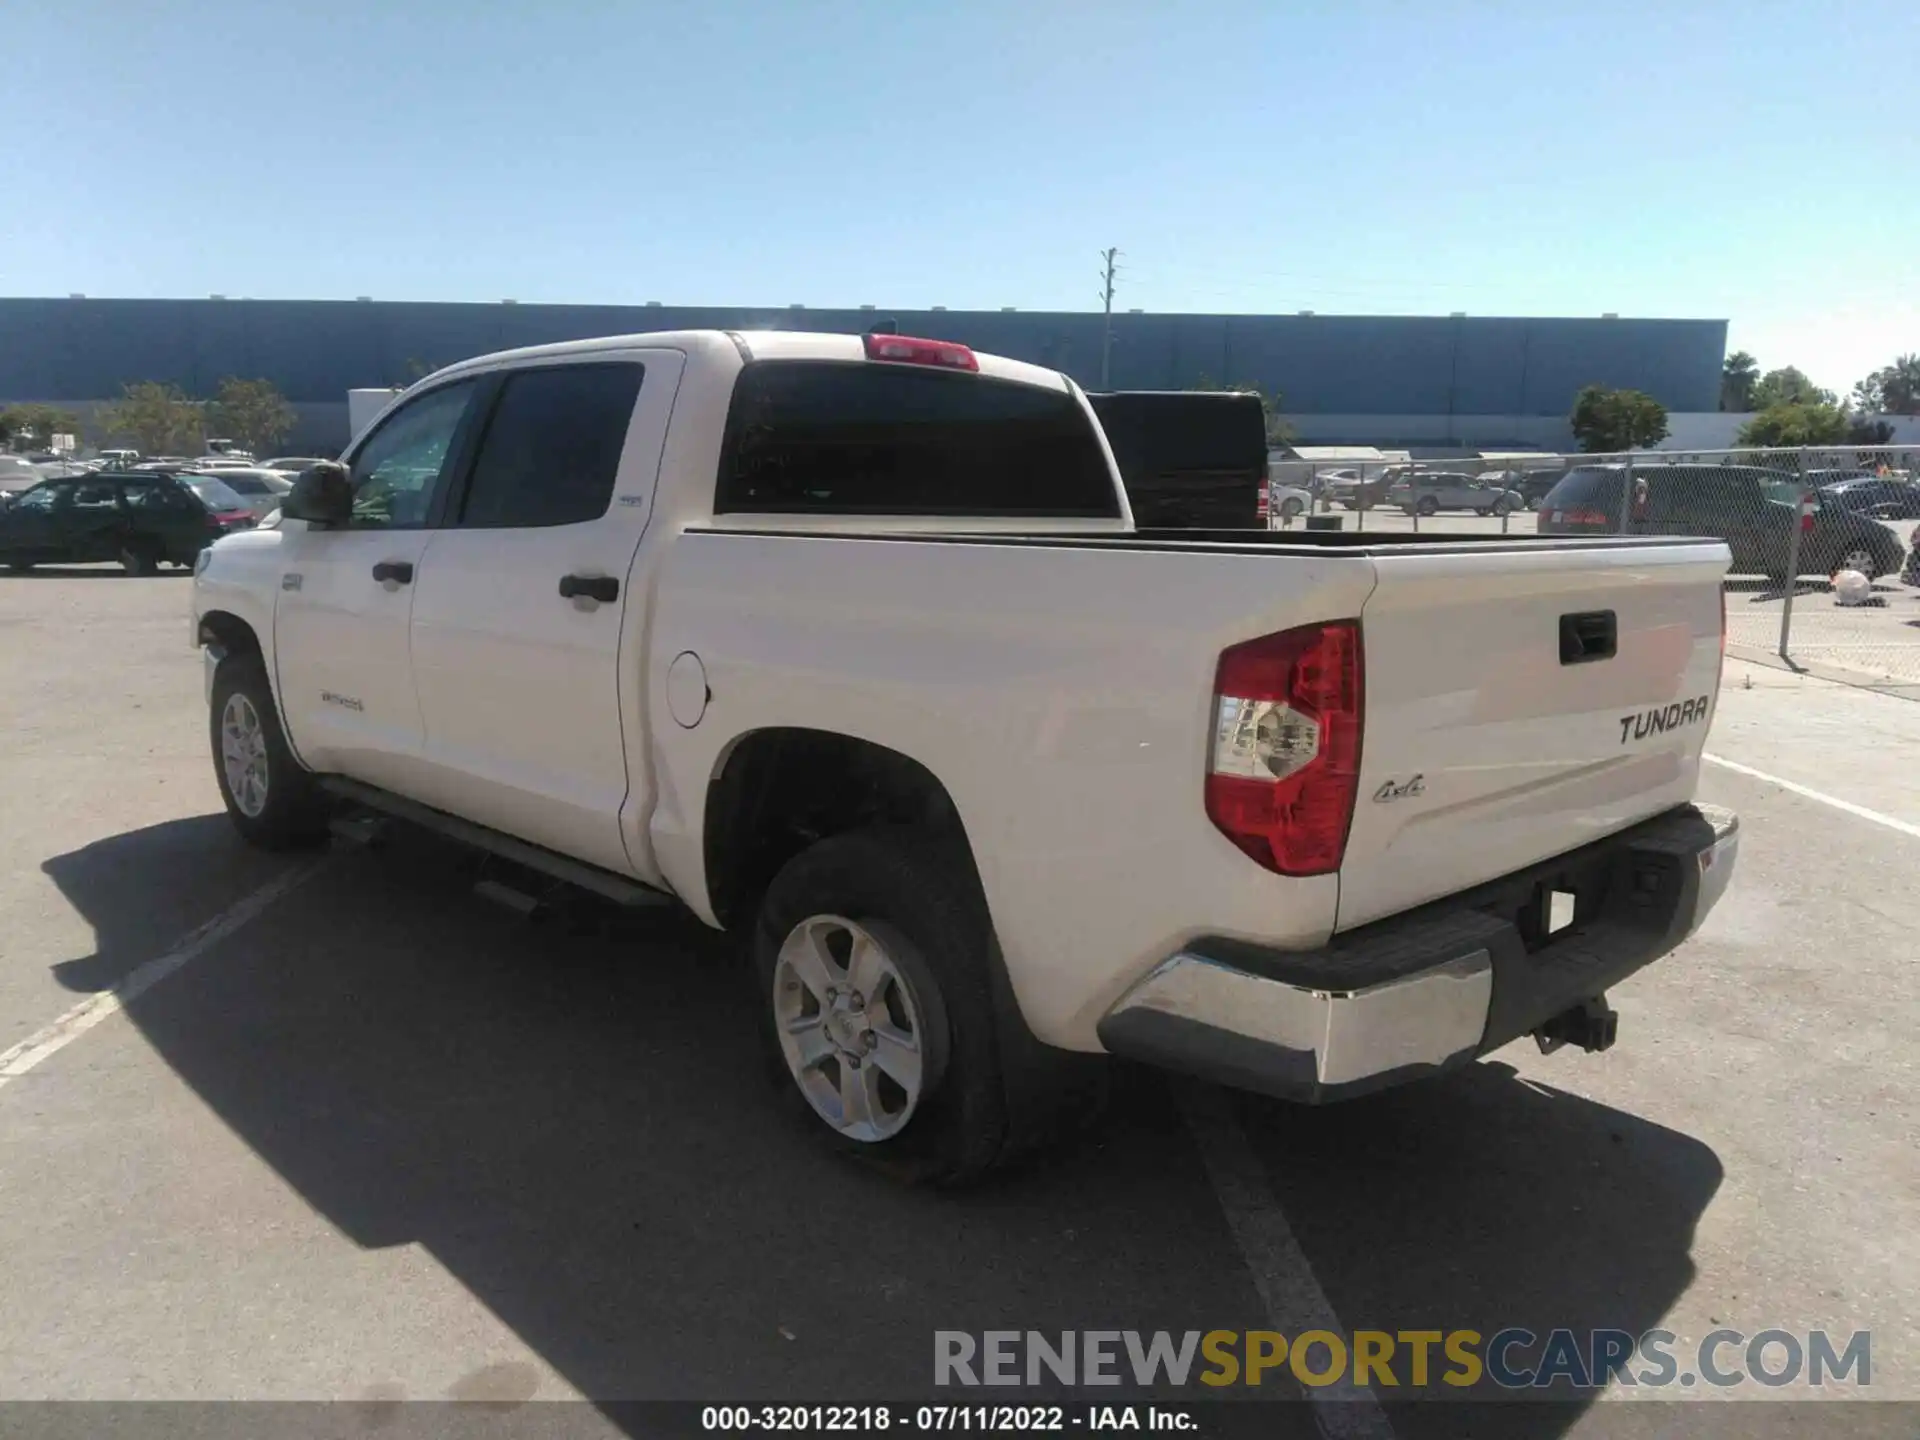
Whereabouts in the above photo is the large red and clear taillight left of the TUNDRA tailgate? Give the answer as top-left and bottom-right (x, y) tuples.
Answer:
(1206, 620), (1361, 876)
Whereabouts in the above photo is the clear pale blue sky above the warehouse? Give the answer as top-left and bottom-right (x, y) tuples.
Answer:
(0, 0), (1920, 390)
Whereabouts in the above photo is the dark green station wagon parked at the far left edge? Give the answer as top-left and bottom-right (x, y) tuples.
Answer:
(0, 470), (253, 574)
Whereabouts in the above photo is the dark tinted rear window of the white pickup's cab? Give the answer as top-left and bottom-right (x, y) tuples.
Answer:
(714, 361), (1119, 516)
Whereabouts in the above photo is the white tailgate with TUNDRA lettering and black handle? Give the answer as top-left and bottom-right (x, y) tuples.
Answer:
(1336, 541), (1728, 929)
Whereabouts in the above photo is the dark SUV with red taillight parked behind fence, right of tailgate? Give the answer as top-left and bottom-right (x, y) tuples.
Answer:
(1534, 463), (1905, 582)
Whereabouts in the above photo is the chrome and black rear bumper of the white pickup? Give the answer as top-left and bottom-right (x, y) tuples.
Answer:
(1100, 806), (1740, 1102)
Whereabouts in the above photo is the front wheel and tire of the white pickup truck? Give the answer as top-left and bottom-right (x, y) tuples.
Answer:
(209, 655), (326, 851)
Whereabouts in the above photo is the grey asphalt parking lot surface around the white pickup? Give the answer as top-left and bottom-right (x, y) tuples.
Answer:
(0, 568), (1920, 1440)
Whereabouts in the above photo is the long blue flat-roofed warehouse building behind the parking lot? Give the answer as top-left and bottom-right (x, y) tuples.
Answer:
(0, 296), (1726, 451)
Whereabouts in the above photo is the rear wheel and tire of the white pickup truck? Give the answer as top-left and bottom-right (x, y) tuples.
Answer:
(753, 828), (1082, 1185)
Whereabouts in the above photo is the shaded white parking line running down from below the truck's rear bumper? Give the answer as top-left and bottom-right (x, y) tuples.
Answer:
(1175, 1081), (1394, 1440)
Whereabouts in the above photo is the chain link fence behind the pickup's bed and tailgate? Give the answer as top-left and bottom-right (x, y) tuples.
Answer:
(1269, 445), (1920, 695)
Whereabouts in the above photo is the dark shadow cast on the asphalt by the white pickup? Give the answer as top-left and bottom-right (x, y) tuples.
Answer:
(46, 818), (1720, 1440)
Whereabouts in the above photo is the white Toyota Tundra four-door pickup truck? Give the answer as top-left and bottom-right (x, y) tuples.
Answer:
(192, 332), (1738, 1181)
